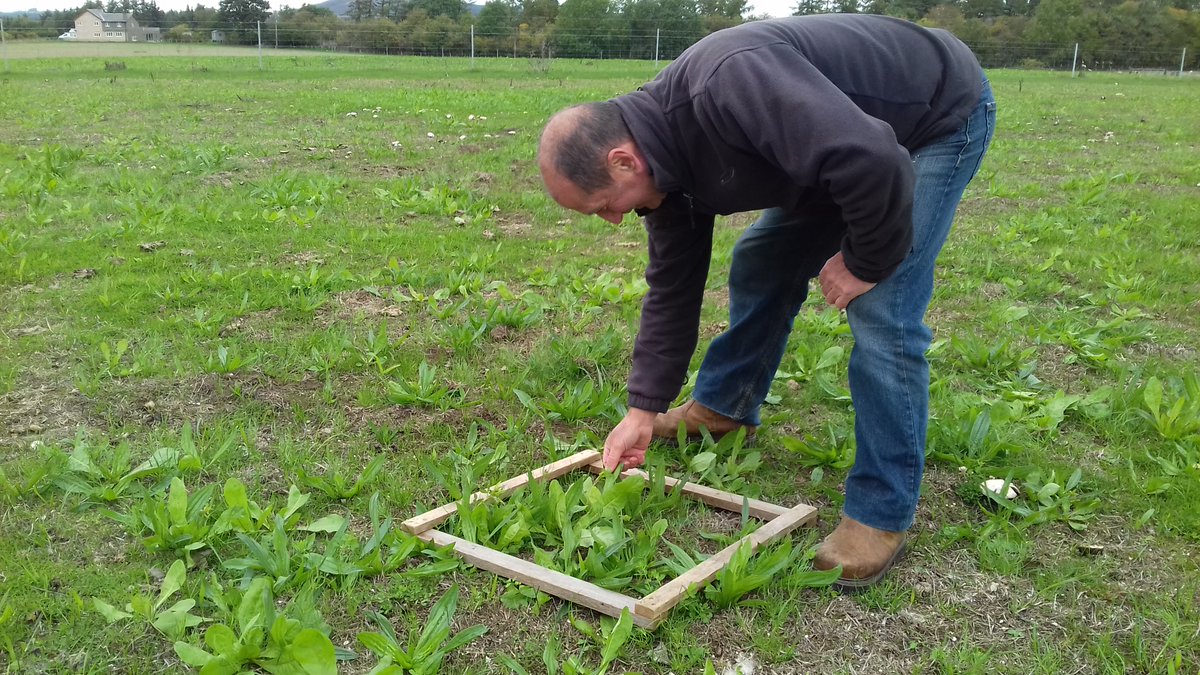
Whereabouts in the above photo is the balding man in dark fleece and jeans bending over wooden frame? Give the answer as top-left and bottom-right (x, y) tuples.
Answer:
(539, 14), (995, 590)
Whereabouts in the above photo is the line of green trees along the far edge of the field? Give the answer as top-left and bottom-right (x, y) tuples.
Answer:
(6, 0), (1200, 68)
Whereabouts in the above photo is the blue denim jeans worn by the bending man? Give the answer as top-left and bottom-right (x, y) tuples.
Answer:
(692, 78), (996, 532)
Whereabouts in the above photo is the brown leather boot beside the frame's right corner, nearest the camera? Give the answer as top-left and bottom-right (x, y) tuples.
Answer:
(812, 515), (906, 592)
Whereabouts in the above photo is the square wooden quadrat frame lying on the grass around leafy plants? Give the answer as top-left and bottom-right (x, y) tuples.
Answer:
(401, 450), (817, 629)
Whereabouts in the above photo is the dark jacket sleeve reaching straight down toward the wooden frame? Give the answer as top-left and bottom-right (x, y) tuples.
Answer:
(629, 193), (713, 412)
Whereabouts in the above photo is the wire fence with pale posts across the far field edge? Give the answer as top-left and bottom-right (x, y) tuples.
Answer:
(0, 22), (1200, 74)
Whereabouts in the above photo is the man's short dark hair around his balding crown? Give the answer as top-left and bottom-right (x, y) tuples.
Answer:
(554, 101), (632, 195)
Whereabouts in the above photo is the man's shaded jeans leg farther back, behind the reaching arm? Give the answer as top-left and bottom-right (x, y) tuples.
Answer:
(692, 209), (845, 425)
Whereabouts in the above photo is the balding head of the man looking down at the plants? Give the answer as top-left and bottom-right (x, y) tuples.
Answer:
(538, 101), (665, 223)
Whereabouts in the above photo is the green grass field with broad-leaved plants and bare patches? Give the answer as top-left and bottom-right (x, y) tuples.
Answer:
(0, 46), (1200, 674)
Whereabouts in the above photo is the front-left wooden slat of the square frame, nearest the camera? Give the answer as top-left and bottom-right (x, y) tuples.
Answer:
(418, 530), (660, 628)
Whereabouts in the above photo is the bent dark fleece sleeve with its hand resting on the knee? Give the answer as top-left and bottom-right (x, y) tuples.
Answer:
(697, 44), (914, 282)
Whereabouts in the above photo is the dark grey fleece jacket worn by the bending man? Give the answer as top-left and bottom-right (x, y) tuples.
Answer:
(613, 14), (983, 412)
